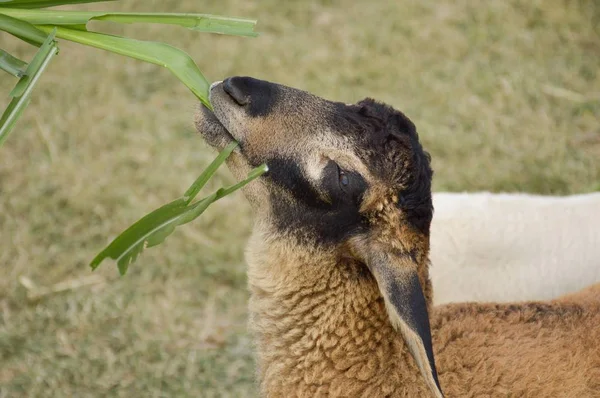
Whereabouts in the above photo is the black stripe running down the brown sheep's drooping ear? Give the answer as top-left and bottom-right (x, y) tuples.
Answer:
(388, 273), (442, 391)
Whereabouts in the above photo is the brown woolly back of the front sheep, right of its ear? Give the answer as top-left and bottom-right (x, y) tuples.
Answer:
(431, 297), (600, 398)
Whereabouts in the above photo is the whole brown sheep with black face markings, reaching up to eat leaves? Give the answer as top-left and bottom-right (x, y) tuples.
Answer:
(195, 77), (600, 398)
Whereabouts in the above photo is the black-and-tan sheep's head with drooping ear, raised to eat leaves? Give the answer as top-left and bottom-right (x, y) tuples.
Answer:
(196, 77), (441, 396)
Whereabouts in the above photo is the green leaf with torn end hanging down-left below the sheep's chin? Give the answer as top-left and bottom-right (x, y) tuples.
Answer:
(90, 165), (268, 275)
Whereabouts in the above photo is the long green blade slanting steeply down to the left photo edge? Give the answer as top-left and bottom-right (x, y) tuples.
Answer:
(0, 28), (58, 146)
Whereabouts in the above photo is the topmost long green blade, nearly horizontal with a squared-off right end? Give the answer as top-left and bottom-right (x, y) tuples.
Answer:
(2, 8), (257, 36)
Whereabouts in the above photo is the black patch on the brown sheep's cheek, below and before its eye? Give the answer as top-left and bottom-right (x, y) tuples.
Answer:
(265, 158), (367, 244)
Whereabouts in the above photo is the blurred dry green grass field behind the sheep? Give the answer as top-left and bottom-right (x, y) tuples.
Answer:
(0, 0), (600, 398)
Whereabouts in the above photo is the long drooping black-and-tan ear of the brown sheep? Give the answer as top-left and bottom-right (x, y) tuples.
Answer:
(367, 252), (444, 397)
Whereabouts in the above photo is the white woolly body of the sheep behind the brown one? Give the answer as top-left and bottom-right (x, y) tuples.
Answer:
(430, 192), (600, 304)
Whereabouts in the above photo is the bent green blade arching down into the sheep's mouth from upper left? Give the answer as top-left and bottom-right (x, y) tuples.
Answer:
(38, 26), (210, 107)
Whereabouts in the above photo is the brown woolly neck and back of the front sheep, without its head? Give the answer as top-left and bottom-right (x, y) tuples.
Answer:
(248, 235), (600, 398)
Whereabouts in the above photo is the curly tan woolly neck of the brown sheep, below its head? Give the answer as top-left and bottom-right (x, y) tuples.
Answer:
(247, 233), (431, 397)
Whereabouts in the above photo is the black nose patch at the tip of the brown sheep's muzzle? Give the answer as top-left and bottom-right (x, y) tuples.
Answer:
(223, 76), (281, 117)
